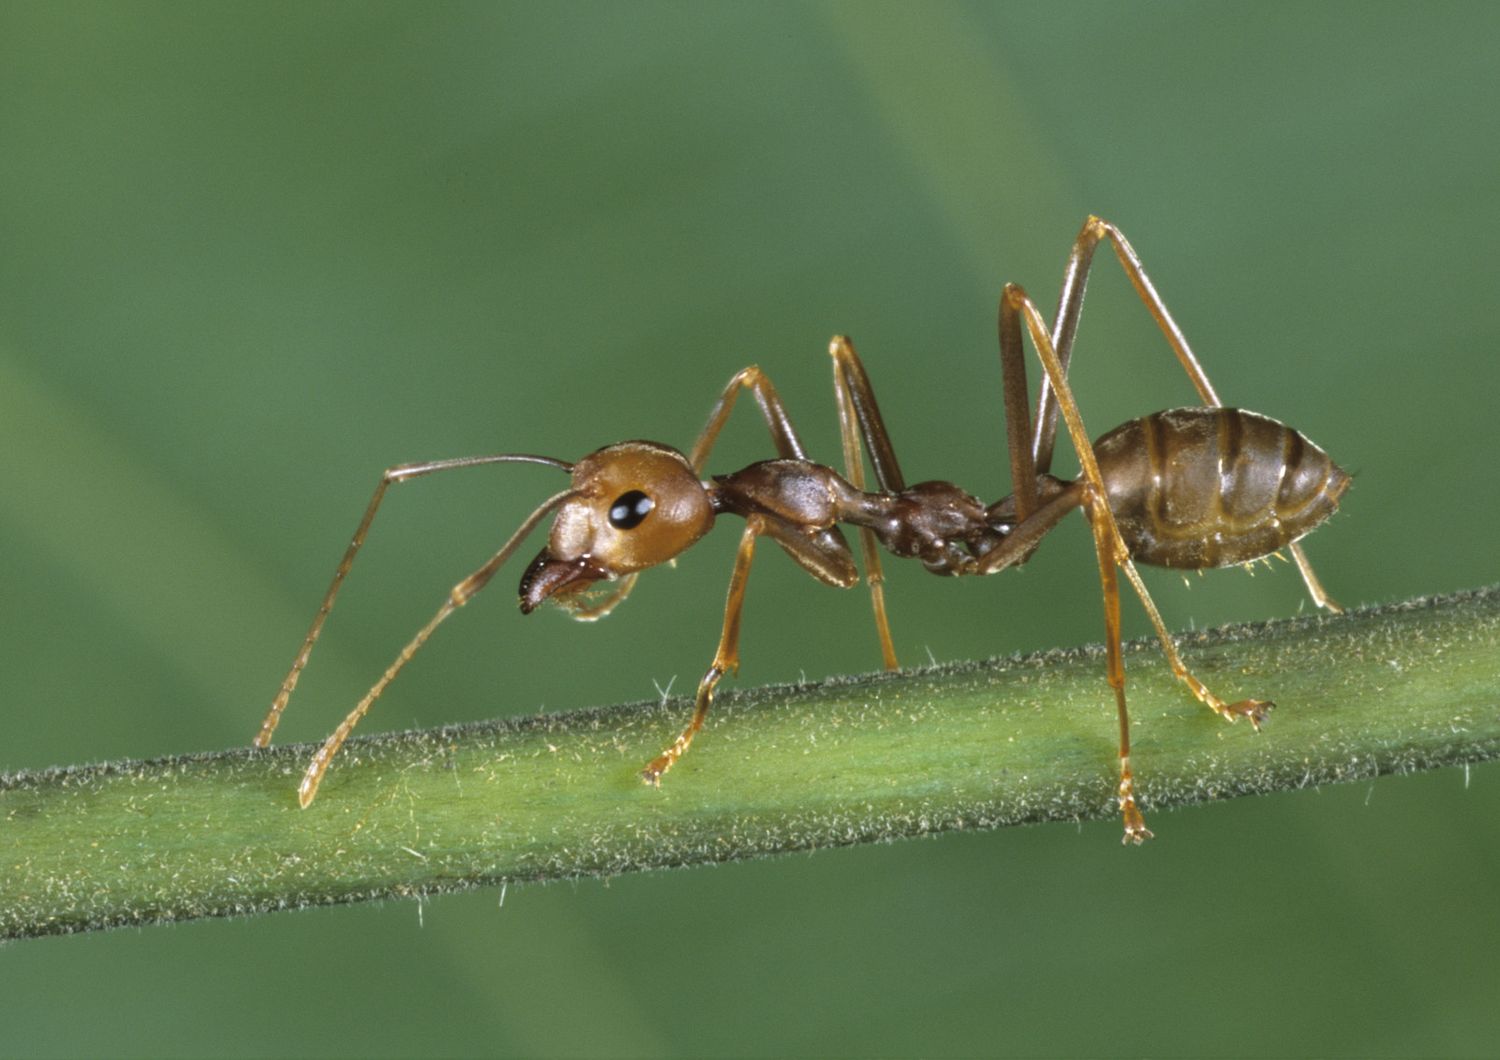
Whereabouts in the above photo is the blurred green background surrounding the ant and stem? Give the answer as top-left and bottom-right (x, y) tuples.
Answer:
(0, 3), (1500, 1056)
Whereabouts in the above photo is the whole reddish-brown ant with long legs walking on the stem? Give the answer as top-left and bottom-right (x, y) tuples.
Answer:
(255, 217), (1350, 844)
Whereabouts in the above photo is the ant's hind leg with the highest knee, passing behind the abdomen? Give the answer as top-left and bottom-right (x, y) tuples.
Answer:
(1032, 216), (1344, 613)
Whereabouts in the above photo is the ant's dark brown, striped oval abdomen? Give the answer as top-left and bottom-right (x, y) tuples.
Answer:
(1094, 406), (1349, 570)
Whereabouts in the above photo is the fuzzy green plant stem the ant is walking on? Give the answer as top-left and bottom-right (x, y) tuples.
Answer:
(0, 588), (1500, 937)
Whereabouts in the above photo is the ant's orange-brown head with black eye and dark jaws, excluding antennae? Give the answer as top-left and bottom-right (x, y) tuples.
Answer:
(521, 442), (714, 613)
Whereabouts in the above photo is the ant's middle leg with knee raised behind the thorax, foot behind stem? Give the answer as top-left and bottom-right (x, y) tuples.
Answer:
(828, 334), (906, 670)
